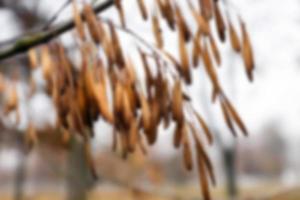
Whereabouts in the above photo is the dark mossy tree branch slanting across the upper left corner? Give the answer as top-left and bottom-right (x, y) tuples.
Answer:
(0, 0), (114, 61)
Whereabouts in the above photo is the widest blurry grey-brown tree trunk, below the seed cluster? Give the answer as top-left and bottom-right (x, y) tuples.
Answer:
(67, 137), (94, 200)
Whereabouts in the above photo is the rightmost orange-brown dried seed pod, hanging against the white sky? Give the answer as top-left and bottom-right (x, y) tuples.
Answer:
(240, 20), (255, 81)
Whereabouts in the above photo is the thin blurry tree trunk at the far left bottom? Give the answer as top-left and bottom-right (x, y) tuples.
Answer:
(14, 152), (26, 200)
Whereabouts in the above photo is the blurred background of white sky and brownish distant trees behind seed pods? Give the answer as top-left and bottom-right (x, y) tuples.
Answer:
(0, 0), (300, 200)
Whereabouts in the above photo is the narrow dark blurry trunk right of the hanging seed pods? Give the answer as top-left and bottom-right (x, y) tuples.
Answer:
(222, 146), (238, 200)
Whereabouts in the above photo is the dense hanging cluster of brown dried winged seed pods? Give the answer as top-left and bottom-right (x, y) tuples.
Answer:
(0, 0), (254, 200)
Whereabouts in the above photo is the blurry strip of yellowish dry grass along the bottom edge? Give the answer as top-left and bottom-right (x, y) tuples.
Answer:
(0, 183), (300, 200)
